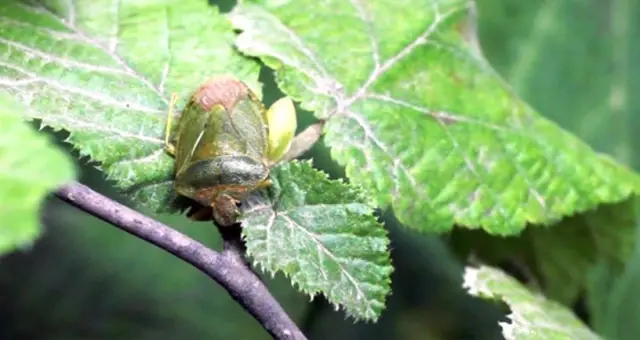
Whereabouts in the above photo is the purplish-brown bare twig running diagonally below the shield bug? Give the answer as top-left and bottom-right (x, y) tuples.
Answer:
(56, 182), (306, 340)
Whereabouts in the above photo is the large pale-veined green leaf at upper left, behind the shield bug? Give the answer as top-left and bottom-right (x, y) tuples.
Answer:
(0, 0), (261, 211)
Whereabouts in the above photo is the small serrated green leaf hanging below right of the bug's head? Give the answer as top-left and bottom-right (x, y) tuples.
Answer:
(243, 161), (392, 320)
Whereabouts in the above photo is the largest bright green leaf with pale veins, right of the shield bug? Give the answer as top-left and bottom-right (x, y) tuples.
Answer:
(230, 0), (640, 235)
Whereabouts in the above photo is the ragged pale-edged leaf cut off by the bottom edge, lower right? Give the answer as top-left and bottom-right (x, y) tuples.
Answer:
(464, 266), (600, 340)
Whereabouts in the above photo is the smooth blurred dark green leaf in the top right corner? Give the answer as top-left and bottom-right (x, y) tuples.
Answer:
(478, 0), (640, 170)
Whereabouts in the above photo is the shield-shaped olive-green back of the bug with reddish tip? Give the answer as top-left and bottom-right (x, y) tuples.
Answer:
(174, 77), (269, 217)
